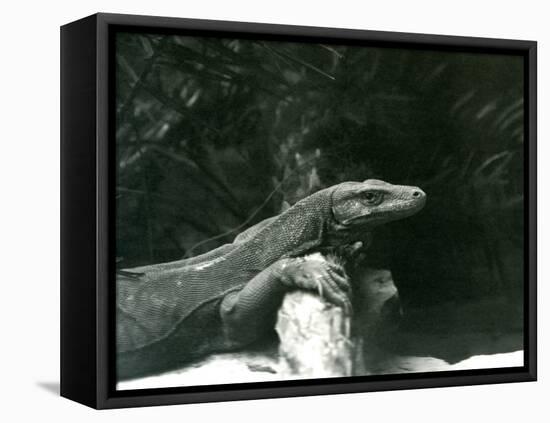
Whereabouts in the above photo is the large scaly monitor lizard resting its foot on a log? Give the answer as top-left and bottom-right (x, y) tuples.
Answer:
(116, 179), (426, 380)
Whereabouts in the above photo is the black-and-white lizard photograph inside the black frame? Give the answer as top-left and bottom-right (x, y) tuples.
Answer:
(113, 29), (527, 391)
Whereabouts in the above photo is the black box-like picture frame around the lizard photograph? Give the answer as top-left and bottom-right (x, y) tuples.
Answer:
(61, 13), (537, 409)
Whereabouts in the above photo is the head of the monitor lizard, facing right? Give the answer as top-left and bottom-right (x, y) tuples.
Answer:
(331, 179), (426, 243)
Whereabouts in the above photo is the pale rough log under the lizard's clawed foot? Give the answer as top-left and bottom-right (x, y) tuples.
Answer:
(275, 266), (397, 378)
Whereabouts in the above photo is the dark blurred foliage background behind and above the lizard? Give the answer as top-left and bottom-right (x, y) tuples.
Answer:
(116, 33), (524, 305)
